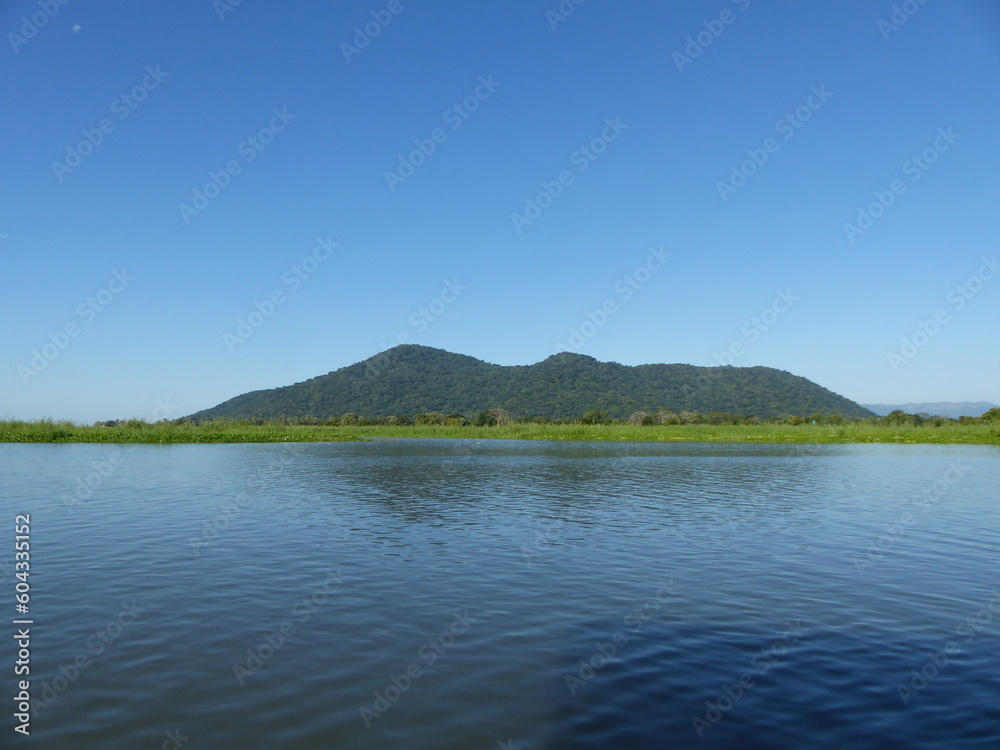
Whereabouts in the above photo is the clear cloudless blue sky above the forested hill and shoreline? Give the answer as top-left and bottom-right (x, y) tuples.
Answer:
(0, 0), (1000, 423)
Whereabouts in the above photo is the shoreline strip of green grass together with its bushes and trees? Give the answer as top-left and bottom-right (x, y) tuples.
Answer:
(0, 410), (1000, 445)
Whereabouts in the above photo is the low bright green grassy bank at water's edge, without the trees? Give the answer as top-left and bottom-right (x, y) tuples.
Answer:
(0, 421), (1000, 445)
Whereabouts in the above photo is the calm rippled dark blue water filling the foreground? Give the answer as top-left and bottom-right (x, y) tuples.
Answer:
(0, 440), (1000, 750)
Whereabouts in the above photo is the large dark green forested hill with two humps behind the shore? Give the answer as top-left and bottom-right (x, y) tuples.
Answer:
(190, 345), (873, 420)
